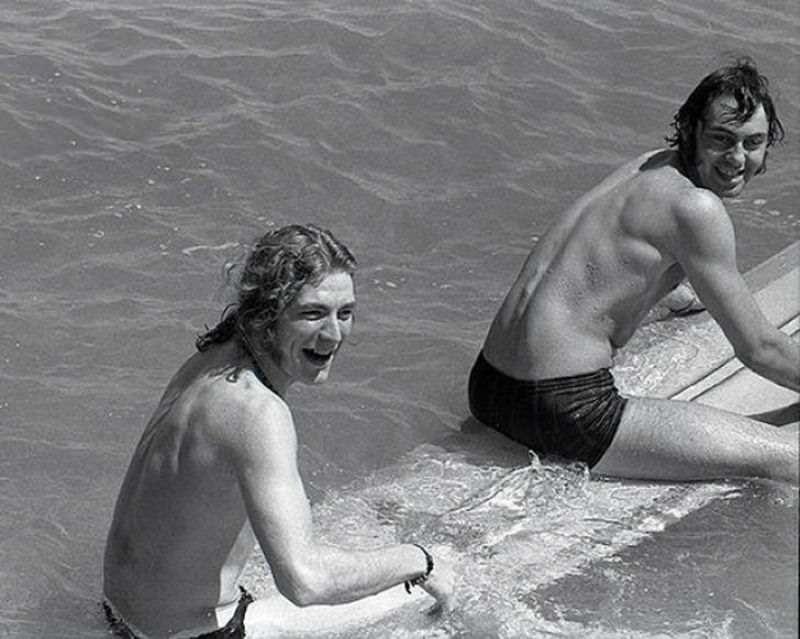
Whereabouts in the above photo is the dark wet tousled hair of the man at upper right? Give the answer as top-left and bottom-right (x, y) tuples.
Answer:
(666, 56), (784, 172)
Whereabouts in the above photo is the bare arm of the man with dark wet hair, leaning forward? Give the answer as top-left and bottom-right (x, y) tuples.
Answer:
(670, 192), (800, 391)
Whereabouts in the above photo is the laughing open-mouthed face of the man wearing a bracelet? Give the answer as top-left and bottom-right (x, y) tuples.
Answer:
(273, 271), (356, 384)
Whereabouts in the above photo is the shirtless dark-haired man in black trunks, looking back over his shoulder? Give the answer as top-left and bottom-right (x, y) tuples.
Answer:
(469, 59), (800, 484)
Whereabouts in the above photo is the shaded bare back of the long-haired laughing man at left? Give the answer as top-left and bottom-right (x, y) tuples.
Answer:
(104, 344), (278, 636)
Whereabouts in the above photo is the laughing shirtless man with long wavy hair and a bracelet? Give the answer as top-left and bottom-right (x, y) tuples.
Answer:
(104, 225), (454, 639)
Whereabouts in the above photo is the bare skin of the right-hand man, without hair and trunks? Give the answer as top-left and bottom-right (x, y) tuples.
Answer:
(478, 84), (800, 485)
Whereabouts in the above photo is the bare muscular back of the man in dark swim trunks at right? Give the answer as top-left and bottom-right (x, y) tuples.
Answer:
(483, 151), (694, 379)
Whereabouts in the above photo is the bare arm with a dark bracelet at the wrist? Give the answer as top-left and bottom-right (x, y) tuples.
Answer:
(225, 398), (452, 607)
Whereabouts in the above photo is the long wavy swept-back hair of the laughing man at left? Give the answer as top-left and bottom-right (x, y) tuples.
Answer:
(195, 224), (357, 351)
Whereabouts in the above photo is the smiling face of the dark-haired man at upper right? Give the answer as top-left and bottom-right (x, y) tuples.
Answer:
(695, 95), (768, 197)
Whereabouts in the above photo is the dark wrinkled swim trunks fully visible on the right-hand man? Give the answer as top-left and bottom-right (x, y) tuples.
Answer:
(469, 353), (628, 468)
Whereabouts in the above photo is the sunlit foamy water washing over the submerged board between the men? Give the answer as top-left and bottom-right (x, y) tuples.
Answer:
(244, 445), (739, 639)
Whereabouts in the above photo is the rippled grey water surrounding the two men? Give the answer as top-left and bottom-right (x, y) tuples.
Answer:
(0, 0), (800, 638)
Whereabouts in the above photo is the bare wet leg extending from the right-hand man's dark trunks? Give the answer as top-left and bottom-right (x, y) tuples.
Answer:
(592, 397), (798, 484)
